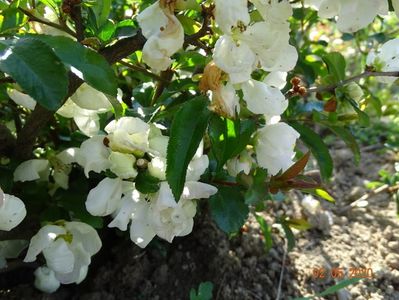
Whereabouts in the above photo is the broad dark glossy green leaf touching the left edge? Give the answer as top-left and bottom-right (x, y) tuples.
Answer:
(0, 38), (68, 110)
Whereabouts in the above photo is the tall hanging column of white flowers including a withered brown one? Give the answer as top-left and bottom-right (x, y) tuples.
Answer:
(200, 0), (299, 176)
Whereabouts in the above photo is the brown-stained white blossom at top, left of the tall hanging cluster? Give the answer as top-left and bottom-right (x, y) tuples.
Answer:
(137, 1), (184, 71)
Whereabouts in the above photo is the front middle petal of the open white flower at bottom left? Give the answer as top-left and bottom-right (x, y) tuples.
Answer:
(43, 238), (75, 274)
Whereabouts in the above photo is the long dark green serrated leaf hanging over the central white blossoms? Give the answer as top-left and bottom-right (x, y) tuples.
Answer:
(166, 96), (211, 201)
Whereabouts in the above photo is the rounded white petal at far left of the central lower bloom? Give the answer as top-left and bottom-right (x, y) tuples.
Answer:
(86, 178), (122, 216)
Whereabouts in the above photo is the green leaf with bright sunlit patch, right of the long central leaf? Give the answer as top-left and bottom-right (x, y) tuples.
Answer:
(208, 115), (256, 170)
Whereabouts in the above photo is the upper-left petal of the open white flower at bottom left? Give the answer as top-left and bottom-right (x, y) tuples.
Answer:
(24, 225), (66, 262)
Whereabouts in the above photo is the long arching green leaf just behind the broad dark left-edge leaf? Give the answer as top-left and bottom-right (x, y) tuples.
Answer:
(28, 35), (118, 96)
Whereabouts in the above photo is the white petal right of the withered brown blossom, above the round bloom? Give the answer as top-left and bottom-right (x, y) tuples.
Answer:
(241, 79), (288, 117)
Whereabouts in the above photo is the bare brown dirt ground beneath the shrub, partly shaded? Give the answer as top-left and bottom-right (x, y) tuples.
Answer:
(0, 144), (399, 300)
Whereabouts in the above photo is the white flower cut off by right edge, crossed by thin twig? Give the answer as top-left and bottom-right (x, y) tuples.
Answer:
(367, 39), (399, 83)
